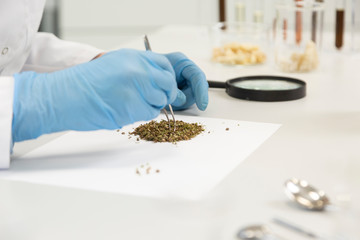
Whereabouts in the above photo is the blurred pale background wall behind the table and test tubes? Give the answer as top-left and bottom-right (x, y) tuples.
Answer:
(42, 0), (360, 49)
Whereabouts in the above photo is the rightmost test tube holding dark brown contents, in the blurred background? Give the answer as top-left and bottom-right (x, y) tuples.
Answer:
(335, 0), (346, 49)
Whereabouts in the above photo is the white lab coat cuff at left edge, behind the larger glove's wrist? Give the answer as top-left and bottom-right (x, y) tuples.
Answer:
(0, 77), (14, 169)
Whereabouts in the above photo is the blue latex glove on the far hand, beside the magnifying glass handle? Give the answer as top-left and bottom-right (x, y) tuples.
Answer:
(165, 53), (209, 111)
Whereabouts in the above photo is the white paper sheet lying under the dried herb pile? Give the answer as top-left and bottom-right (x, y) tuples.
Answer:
(0, 115), (280, 200)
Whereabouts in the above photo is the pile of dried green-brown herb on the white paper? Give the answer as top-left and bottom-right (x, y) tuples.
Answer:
(130, 120), (205, 143)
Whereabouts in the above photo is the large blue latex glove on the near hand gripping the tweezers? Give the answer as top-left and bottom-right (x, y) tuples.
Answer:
(13, 49), (186, 142)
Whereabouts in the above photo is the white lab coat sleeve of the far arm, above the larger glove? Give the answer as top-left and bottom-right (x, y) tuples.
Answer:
(22, 32), (104, 72)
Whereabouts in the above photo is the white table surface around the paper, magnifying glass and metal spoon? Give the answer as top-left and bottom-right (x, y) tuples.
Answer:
(0, 26), (360, 240)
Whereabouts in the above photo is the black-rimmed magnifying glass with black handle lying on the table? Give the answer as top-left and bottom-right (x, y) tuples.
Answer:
(208, 75), (306, 102)
